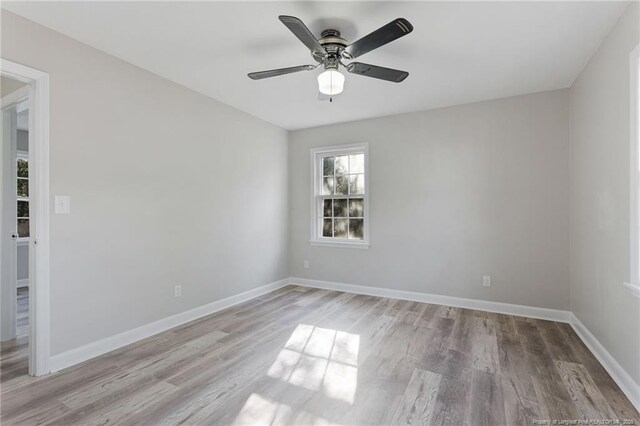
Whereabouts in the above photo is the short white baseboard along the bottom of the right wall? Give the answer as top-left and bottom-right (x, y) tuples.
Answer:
(571, 312), (640, 412)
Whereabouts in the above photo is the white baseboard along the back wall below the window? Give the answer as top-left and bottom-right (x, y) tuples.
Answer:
(290, 278), (571, 323)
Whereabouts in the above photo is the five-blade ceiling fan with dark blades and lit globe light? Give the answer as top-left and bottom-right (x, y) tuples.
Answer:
(247, 15), (413, 100)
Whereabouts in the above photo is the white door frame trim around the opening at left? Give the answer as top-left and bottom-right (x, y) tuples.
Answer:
(0, 58), (51, 376)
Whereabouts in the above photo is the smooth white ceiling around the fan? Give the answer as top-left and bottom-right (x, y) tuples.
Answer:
(2, 1), (628, 129)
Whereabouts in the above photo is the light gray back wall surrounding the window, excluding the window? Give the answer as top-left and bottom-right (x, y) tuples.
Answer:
(289, 90), (569, 309)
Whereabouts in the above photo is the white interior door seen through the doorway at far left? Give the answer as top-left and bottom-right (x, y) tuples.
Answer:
(0, 106), (18, 341)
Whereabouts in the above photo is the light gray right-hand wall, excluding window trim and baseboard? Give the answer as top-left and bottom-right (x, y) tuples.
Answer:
(570, 2), (640, 383)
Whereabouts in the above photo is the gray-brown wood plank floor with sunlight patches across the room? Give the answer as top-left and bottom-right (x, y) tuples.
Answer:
(1, 286), (640, 425)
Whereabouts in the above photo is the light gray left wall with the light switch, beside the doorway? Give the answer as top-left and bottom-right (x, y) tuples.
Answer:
(2, 11), (288, 355)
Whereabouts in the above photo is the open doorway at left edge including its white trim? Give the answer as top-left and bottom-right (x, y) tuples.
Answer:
(0, 59), (50, 376)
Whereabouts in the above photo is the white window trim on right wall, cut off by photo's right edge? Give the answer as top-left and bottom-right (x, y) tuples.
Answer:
(624, 44), (640, 296)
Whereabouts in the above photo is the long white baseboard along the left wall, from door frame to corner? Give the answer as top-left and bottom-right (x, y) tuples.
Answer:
(50, 279), (290, 372)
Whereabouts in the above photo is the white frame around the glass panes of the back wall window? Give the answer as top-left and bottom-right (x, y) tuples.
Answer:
(309, 142), (371, 249)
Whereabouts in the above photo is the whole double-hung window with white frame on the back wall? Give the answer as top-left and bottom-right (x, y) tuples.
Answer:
(311, 144), (369, 248)
